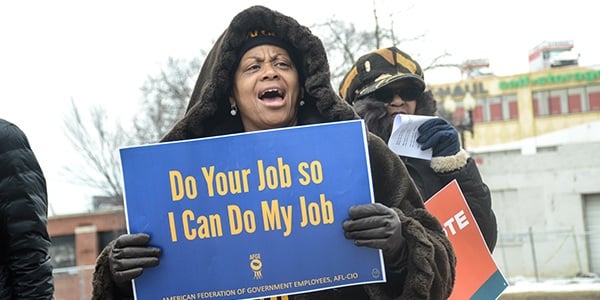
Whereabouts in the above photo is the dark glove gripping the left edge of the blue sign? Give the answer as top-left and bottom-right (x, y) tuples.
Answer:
(108, 233), (162, 289)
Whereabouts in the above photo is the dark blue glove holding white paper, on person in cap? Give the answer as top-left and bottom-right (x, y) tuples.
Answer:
(417, 118), (460, 156)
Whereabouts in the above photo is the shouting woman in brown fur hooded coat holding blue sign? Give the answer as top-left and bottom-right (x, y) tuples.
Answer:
(92, 6), (456, 300)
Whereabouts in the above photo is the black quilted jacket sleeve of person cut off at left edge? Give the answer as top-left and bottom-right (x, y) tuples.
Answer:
(0, 119), (54, 299)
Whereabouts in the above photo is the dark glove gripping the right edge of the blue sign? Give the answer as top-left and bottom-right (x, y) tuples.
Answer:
(342, 203), (406, 261)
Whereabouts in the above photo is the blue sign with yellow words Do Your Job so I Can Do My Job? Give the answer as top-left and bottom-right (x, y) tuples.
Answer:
(120, 120), (385, 299)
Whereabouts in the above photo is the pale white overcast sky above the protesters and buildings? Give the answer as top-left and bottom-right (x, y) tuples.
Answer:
(0, 0), (600, 214)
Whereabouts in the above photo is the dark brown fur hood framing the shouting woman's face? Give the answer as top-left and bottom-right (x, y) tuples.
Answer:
(162, 6), (358, 142)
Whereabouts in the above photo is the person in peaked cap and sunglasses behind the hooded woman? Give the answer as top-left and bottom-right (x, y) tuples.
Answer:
(339, 47), (498, 252)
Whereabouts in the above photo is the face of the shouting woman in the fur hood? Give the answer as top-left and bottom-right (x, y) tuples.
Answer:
(230, 45), (300, 131)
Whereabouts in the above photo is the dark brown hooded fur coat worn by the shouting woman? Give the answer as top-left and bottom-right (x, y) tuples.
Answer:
(93, 6), (455, 300)
